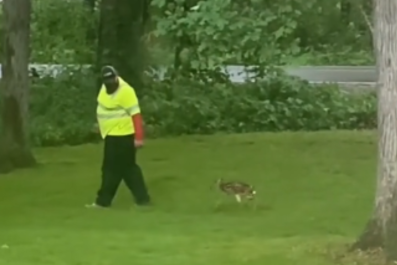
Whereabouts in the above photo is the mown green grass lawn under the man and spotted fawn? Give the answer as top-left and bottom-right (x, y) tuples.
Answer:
(0, 132), (376, 265)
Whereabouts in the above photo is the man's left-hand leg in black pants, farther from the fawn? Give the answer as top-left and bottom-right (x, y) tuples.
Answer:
(95, 136), (122, 207)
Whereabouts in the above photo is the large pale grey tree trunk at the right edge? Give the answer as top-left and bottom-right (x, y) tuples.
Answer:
(354, 0), (397, 261)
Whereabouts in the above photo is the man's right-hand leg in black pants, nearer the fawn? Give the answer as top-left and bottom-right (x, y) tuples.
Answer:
(119, 136), (150, 205)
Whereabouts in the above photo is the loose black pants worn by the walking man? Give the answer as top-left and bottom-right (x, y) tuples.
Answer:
(96, 135), (150, 207)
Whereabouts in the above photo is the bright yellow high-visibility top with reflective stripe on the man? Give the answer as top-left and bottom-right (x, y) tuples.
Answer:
(96, 77), (141, 139)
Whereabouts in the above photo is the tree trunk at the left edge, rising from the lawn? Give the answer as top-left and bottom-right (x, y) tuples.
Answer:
(0, 0), (36, 173)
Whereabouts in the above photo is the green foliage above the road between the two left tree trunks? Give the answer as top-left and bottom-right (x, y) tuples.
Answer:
(31, 0), (98, 64)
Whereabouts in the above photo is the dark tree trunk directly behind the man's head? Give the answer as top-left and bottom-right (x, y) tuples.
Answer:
(97, 0), (148, 94)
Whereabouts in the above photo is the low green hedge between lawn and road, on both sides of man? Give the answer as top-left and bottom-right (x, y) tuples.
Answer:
(3, 69), (376, 146)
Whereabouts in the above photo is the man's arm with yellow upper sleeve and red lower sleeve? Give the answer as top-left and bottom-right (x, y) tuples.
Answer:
(120, 88), (144, 141)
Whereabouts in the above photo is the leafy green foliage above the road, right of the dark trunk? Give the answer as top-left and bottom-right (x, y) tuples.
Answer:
(152, 0), (373, 69)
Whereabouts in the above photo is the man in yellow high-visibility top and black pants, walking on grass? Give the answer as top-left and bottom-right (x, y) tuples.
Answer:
(87, 66), (150, 207)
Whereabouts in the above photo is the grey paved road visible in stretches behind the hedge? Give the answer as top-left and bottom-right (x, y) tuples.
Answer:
(0, 64), (377, 83)
